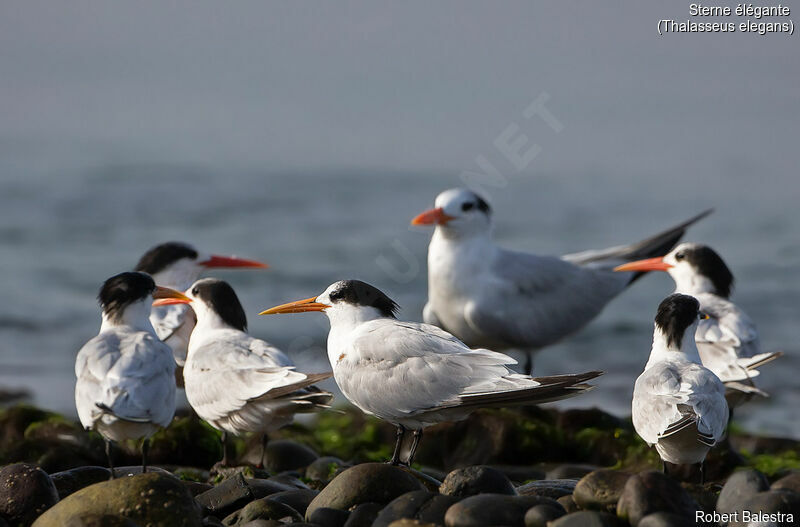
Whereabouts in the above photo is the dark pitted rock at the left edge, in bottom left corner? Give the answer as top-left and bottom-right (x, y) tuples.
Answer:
(0, 463), (58, 525)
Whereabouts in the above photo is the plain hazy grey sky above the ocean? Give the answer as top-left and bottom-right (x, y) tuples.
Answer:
(0, 0), (800, 192)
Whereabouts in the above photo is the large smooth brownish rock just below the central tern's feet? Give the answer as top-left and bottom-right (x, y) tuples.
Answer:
(306, 463), (422, 519)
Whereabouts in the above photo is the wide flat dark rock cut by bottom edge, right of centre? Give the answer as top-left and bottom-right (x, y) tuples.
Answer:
(444, 494), (559, 527)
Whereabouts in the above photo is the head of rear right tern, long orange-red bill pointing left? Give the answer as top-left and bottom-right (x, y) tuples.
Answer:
(614, 243), (733, 298)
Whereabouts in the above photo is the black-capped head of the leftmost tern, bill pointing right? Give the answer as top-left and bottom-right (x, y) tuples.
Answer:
(97, 271), (189, 322)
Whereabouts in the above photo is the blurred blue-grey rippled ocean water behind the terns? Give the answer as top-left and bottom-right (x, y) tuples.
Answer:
(0, 165), (800, 438)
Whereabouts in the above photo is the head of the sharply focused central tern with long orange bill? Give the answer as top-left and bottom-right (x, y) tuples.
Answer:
(260, 280), (399, 320)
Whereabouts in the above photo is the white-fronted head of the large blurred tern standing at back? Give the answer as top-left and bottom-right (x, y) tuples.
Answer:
(411, 188), (492, 236)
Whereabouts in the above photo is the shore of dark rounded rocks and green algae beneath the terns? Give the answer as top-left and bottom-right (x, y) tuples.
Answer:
(0, 405), (800, 527)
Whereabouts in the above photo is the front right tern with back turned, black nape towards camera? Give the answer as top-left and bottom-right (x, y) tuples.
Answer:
(632, 294), (728, 480)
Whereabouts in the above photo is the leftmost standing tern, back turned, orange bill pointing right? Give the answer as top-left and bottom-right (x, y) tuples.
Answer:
(75, 272), (190, 477)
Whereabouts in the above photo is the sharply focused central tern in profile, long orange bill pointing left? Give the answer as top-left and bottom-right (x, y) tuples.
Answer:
(261, 280), (602, 465)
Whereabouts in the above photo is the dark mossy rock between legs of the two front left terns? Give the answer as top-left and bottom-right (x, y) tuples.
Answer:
(149, 415), (222, 467)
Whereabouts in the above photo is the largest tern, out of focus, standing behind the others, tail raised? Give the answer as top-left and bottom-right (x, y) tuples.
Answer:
(411, 189), (711, 374)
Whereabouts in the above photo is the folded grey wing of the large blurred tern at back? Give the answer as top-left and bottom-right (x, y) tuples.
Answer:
(465, 251), (629, 348)
